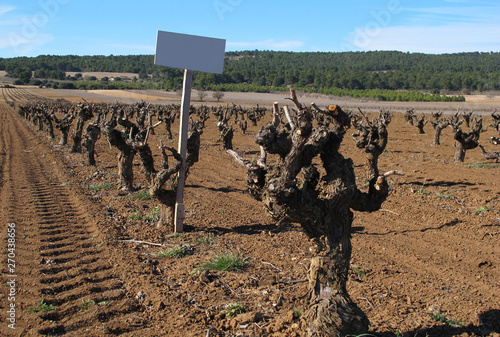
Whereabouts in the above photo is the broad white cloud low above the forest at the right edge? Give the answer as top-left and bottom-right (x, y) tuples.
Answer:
(347, 23), (500, 54)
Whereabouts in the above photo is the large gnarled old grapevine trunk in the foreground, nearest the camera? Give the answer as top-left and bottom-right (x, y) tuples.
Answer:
(228, 94), (396, 336)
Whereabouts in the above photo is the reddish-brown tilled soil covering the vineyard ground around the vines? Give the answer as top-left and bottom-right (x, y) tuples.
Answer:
(0, 89), (500, 337)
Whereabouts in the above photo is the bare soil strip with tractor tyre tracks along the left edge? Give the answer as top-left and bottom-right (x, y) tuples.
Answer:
(0, 102), (144, 336)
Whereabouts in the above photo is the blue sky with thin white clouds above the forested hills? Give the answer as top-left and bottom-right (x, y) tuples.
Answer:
(0, 0), (500, 57)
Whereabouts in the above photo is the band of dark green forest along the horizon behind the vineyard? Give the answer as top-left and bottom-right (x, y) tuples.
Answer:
(0, 50), (500, 101)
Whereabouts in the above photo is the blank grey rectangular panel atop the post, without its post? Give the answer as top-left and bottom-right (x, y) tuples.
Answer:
(155, 30), (226, 74)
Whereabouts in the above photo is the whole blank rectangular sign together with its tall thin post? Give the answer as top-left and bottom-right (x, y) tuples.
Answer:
(154, 31), (226, 233)
